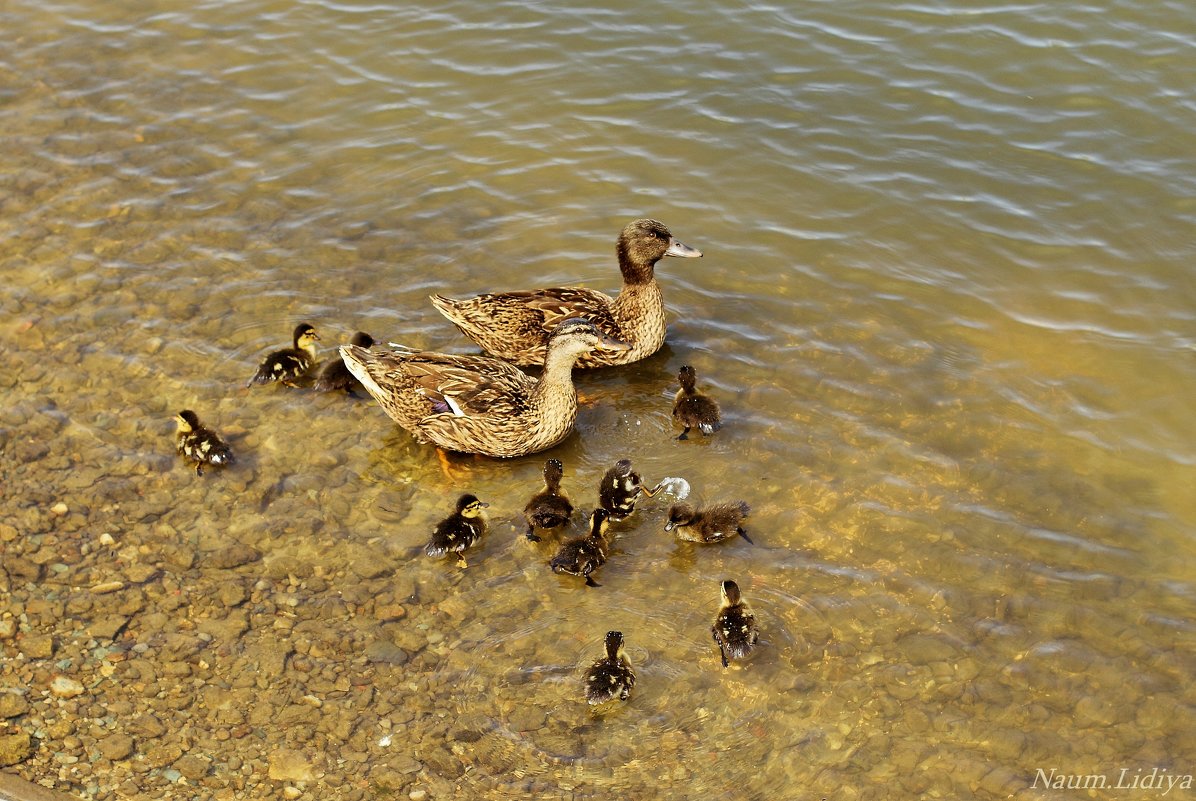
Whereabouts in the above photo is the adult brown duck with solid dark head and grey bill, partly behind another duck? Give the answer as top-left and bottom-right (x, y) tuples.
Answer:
(432, 220), (702, 367)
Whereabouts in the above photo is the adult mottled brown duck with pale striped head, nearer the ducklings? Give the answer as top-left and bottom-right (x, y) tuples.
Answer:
(341, 319), (627, 457)
